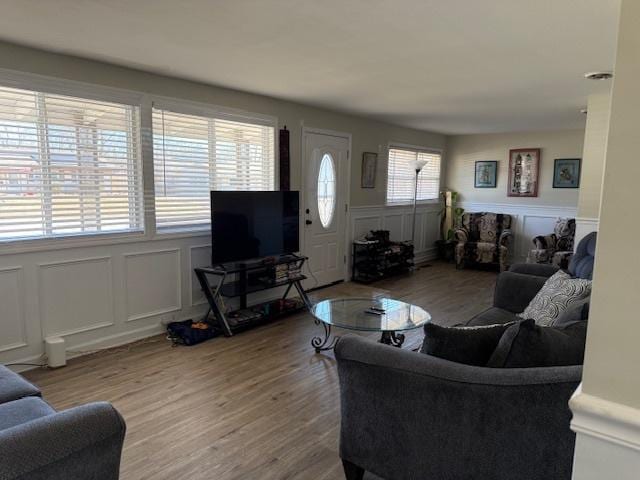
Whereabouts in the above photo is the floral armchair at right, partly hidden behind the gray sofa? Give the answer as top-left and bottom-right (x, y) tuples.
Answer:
(527, 218), (576, 268)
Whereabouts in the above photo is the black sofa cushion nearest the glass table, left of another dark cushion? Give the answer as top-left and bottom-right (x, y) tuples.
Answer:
(420, 323), (512, 366)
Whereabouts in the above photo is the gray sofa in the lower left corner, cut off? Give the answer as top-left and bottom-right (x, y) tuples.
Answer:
(0, 366), (125, 480)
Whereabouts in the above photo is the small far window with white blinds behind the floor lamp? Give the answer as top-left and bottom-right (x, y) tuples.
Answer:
(387, 147), (442, 203)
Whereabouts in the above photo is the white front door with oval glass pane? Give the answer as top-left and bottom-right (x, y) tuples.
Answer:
(303, 132), (349, 287)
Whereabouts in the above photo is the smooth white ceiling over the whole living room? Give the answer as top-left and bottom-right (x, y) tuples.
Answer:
(0, 0), (620, 133)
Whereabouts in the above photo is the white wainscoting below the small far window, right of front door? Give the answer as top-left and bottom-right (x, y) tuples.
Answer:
(350, 203), (442, 263)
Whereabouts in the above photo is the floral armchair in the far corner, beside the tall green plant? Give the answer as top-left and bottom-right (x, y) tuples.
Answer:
(455, 212), (512, 271)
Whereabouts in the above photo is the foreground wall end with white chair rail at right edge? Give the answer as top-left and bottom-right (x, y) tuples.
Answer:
(571, 0), (640, 480)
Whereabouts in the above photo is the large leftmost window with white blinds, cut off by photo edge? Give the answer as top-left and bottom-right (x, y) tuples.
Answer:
(0, 87), (144, 241)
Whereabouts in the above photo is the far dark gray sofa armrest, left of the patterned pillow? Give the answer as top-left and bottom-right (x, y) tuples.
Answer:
(493, 271), (547, 313)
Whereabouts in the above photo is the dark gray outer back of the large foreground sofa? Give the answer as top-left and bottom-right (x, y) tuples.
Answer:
(335, 335), (582, 480)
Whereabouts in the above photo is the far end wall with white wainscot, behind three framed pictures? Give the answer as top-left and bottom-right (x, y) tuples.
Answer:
(444, 130), (584, 262)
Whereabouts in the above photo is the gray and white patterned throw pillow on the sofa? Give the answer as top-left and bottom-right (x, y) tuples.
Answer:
(518, 270), (591, 326)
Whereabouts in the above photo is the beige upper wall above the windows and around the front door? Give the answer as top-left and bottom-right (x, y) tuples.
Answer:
(0, 41), (446, 206)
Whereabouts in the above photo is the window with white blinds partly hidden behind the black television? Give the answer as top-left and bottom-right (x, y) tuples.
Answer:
(153, 108), (275, 231)
